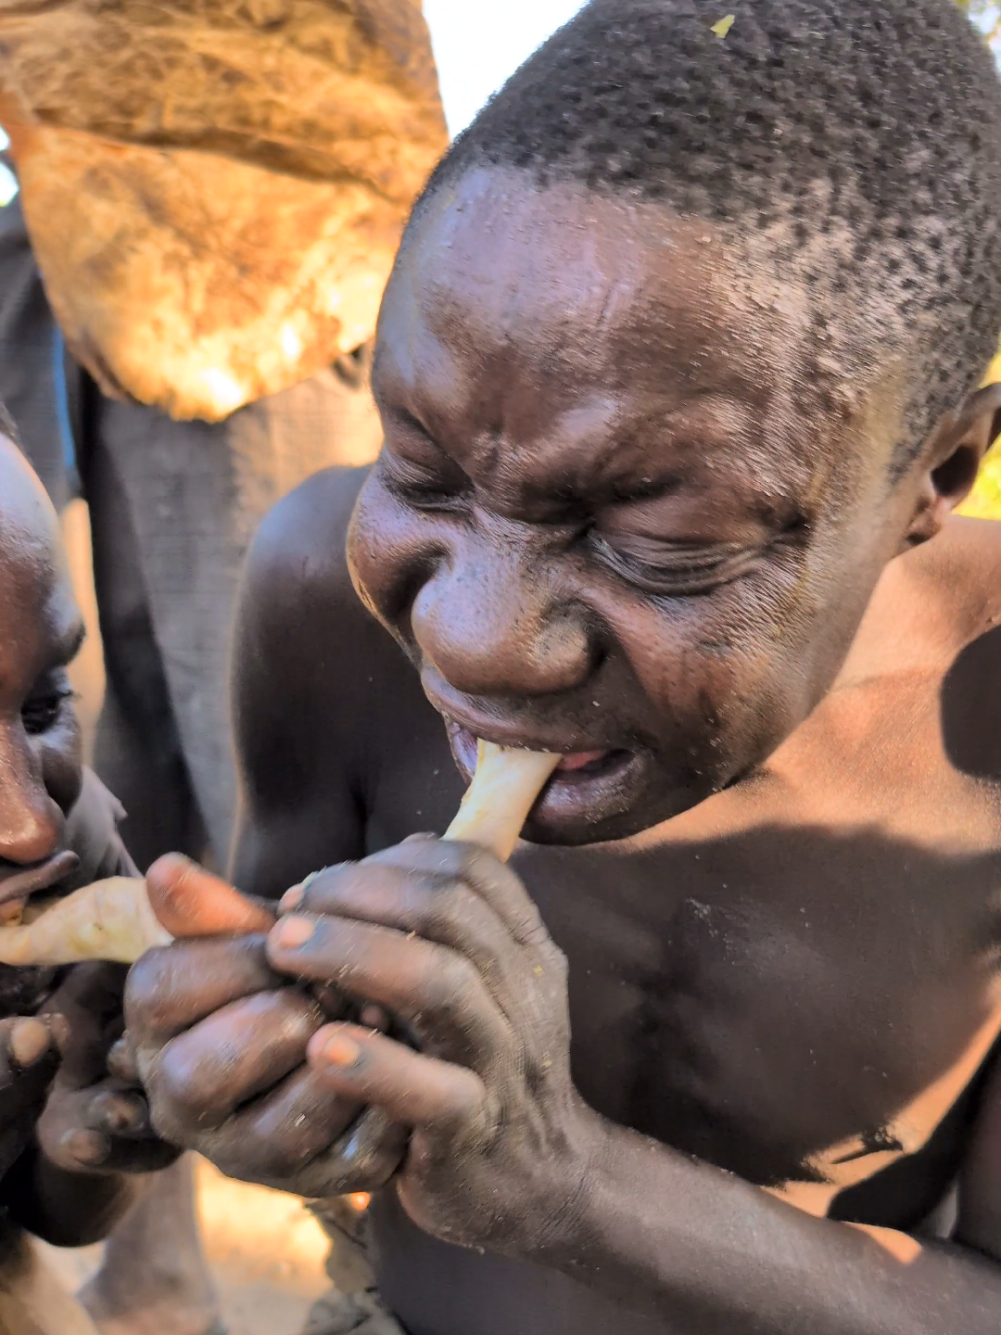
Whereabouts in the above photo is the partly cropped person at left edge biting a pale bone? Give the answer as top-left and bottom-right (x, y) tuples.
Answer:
(0, 424), (178, 1335)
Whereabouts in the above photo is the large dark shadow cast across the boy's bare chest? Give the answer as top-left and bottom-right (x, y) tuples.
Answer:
(525, 828), (1001, 1183)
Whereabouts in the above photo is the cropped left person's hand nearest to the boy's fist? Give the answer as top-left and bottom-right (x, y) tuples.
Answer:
(37, 964), (180, 1173)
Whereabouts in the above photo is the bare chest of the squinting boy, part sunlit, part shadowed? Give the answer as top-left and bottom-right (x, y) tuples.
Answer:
(379, 640), (1001, 1217)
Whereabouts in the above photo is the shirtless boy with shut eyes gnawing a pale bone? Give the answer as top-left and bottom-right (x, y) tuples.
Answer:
(127, 0), (1001, 1335)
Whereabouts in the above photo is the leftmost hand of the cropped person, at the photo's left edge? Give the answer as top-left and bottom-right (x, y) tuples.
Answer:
(0, 1016), (65, 1177)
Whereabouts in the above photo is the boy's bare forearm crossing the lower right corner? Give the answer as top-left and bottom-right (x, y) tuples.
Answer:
(522, 1124), (1001, 1335)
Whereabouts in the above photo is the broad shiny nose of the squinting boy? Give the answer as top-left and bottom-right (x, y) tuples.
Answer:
(411, 551), (594, 696)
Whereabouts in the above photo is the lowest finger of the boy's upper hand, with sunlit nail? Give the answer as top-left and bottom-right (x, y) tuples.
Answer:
(308, 1024), (486, 1128)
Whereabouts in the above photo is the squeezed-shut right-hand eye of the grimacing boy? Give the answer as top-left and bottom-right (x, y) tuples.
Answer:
(589, 530), (761, 597)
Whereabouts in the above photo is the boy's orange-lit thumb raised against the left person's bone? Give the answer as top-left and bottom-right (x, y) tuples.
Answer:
(145, 853), (275, 937)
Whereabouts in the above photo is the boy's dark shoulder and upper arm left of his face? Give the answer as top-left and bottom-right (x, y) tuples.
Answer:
(232, 469), (395, 898)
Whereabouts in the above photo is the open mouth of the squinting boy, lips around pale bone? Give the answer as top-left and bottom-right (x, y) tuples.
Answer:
(446, 718), (645, 834)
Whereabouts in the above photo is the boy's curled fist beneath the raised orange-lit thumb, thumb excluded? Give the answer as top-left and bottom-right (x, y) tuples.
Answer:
(125, 936), (404, 1197)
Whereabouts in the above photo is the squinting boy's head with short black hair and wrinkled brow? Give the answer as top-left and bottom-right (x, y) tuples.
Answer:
(351, 0), (1001, 841)
